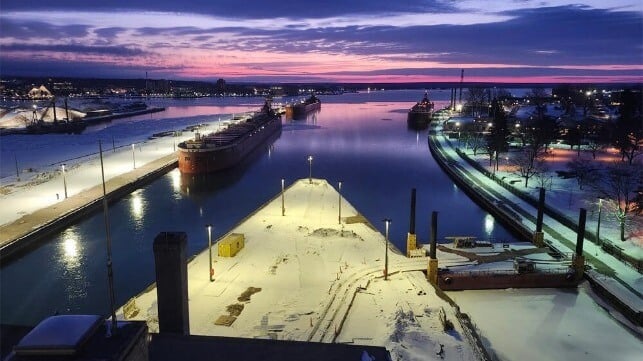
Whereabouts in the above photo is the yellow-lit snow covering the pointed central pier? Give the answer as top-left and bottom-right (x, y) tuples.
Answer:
(118, 179), (484, 360)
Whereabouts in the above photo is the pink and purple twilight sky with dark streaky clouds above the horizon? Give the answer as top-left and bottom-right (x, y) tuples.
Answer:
(0, 0), (643, 83)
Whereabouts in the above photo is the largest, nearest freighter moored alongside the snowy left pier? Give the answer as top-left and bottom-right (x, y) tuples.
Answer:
(178, 101), (281, 174)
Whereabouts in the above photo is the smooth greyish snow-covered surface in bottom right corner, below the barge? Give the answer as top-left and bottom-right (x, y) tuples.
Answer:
(449, 283), (643, 361)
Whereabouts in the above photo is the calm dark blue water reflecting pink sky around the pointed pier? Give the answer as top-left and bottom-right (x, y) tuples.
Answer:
(0, 90), (513, 325)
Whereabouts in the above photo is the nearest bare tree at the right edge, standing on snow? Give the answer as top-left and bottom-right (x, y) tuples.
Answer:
(593, 162), (643, 241)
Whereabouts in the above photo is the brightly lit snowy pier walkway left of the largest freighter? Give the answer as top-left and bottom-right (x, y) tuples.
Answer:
(0, 119), (209, 262)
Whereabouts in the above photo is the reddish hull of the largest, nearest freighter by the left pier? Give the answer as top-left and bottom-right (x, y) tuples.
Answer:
(179, 117), (281, 174)
